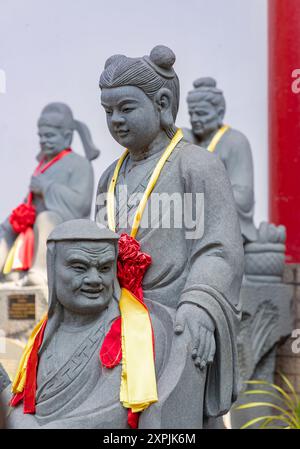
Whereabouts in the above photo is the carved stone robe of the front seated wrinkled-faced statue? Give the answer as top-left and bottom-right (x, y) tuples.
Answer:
(2, 300), (209, 429)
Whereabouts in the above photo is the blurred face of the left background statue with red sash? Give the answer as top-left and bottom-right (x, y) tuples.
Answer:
(38, 125), (72, 158)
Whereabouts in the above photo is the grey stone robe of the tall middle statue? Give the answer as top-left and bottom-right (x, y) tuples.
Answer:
(96, 141), (244, 416)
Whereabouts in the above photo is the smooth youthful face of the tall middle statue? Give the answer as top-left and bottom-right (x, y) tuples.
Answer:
(101, 86), (161, 151)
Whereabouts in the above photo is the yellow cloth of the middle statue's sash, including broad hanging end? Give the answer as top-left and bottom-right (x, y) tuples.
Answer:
(107, 129), (183, 412)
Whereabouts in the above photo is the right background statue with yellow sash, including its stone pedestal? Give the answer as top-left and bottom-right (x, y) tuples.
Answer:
(184, 78), (292, 428)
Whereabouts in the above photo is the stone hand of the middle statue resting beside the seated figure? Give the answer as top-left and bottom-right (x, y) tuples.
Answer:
(174, 304), (216, 370)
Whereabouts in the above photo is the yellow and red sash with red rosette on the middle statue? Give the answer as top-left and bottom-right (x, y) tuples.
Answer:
(100, 129), (183, 428)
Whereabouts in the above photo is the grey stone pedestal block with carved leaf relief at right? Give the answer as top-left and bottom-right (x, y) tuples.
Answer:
(231, 280), (293, 428)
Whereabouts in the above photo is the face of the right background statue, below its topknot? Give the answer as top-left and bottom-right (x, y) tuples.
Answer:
(188, 100), (222, 138)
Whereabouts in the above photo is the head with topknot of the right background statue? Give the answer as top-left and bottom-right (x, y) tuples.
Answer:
(187, 78), (226, 138)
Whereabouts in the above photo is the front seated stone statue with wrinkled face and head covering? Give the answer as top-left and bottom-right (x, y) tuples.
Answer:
(2, 220), (233, 429)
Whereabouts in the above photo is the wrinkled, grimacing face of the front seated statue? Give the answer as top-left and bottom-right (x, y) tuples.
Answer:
(55, 241), (116, 315)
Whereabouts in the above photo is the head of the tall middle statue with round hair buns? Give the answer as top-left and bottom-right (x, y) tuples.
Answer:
(99, 45), (179, 150)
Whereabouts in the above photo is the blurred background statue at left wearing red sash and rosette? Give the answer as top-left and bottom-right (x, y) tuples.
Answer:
(0, 103), (99, 286)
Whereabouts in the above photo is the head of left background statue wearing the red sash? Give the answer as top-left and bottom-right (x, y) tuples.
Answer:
(38, 103), (74, 157)
